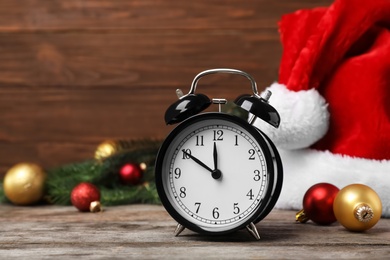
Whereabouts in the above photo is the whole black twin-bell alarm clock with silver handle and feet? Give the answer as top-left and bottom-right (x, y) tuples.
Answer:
(155, 68), (283, 239)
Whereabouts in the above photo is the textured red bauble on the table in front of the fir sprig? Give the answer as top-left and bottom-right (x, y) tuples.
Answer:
(70, 182), (100, 211)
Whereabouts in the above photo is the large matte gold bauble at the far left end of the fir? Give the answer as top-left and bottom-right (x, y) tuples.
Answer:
(3, 163), (46, 205)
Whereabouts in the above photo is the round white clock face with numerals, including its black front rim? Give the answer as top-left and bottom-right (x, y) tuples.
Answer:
(155, 113), (274, 233)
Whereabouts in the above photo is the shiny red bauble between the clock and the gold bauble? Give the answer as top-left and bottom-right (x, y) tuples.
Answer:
(303, 183), (339, 225)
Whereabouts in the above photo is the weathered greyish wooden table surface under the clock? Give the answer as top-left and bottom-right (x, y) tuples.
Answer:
(0, 205), (390, 259)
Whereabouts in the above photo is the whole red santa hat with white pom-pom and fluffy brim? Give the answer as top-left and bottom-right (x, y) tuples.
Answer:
(255, 0), (390, 217)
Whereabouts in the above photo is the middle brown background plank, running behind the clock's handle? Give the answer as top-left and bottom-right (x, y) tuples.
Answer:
(0, 30), (281, 87)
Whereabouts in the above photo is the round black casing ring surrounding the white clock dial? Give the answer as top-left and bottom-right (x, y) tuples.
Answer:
(155, 112), (283, 235)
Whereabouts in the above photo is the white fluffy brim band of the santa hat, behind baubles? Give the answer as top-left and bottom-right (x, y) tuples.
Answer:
(276, 149), (390, 218)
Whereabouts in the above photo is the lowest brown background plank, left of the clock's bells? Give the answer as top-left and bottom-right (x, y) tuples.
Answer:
(0, 89), (169, 171)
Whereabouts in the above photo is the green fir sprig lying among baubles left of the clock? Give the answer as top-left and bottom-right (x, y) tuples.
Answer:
(0, 140), (161, 206)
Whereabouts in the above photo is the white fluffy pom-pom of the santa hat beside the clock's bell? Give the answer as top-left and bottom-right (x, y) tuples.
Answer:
(254, 83), (329, 149)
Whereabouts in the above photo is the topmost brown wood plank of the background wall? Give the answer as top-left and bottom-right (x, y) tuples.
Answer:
(0, 0), (332, 31)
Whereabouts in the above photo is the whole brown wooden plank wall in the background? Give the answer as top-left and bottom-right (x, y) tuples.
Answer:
(0, 0), (331, 176)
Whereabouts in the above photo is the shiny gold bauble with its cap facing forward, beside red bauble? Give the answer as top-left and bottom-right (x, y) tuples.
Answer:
(333, 184), (382, 231)
